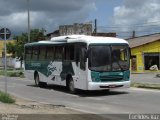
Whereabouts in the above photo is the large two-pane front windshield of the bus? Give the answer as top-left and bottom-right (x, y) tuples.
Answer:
(89, 45), (129, 71)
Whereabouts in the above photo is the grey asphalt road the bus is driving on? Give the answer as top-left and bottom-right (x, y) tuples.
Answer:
(0, 77), (160, 118)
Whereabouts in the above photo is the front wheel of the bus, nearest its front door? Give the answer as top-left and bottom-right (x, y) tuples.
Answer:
(68, 77), (76, 94)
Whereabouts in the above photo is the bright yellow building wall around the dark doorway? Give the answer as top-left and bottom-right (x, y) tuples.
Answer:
(131, 40), (160, 72)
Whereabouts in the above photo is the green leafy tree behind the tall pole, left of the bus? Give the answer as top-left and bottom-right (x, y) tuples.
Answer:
(7, 28), (45, 67)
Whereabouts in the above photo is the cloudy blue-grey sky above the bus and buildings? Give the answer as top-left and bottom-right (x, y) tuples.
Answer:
(0, 0), (160, 38)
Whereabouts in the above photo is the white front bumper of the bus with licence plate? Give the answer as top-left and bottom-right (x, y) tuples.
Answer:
(88, 81), (130, 90)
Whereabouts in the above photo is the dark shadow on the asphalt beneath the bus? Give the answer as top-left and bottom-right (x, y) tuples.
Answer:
(27, 85), (129, 97)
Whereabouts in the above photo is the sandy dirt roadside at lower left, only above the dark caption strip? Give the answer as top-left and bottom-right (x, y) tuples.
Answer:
(0, 97), (80, 114)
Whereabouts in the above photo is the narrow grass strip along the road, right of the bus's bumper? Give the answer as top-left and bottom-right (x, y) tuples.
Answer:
(131, 82), (160, 90)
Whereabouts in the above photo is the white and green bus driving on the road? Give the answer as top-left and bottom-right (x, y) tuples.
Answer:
(25, 35), (130, 93)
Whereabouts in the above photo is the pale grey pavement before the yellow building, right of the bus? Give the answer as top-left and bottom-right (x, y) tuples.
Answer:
(131, 73), (160, 84)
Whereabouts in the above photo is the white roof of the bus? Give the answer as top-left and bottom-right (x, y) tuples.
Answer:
(25, 35), (128, 46)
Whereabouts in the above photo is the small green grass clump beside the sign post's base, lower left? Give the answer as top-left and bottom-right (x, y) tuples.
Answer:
(0, 91), (15, 104)
